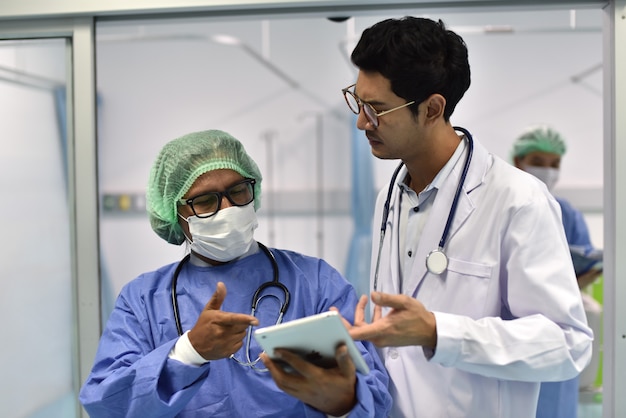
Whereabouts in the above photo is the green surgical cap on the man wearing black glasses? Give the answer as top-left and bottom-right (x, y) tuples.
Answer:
(146, 130), (262, 245)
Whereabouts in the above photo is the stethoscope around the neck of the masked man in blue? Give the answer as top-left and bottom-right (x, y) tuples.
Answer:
(170, 242), (291, 371)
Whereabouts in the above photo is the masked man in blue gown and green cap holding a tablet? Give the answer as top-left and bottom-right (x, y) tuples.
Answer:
(80, 130), (391, 418)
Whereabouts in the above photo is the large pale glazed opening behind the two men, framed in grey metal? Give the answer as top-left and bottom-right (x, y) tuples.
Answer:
(96, 9), (603, 418)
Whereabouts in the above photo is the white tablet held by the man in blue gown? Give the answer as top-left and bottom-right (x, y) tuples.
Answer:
(254, 311), (369, 374)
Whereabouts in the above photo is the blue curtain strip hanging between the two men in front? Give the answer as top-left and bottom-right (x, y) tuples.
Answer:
(346, 116), (376, 295)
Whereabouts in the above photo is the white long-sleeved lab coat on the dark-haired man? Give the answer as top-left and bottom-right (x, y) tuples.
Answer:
(371, 142), (593, 418)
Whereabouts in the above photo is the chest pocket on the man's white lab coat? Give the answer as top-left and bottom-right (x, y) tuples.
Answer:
(444, 258), (494, 319)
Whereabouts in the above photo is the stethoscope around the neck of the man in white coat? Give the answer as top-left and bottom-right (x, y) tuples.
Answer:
(374, 126), (474, 290)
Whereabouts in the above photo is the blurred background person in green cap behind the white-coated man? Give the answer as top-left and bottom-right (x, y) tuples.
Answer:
(512, 125), (602, 418)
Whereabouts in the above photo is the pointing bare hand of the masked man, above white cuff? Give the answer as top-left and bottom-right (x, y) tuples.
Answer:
(189, 282), (259, 360)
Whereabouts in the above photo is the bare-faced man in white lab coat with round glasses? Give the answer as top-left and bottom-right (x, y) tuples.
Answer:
(343, 18), (593, 418)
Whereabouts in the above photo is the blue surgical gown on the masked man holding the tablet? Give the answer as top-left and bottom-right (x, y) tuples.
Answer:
(79, 249), (391, 418)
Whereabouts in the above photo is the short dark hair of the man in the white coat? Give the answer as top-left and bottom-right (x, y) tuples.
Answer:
(351, 16), (470, 122)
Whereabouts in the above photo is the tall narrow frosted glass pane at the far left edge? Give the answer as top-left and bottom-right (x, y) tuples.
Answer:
(0, 39), (77, 418)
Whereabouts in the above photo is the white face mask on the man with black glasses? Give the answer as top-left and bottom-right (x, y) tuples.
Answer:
(182, 204), (259, 262)
